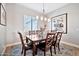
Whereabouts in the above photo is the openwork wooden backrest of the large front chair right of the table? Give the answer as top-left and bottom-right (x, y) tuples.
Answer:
(45, 33), (55, 48)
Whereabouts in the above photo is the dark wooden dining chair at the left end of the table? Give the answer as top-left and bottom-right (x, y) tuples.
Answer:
(18, 32), (32, 56)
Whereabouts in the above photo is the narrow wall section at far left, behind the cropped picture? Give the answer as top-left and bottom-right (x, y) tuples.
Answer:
(0, 4), (6, 55)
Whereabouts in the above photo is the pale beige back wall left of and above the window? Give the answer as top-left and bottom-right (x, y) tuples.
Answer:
(6, 3), (40, 45)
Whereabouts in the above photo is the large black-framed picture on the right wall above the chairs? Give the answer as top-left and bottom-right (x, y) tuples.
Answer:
(51, 13), (67, 34)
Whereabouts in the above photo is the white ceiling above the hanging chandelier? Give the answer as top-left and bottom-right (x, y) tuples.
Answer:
(20, 3), (68, 14)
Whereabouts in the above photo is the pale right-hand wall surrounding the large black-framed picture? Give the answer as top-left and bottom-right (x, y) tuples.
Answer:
(48, 3), (79, 45)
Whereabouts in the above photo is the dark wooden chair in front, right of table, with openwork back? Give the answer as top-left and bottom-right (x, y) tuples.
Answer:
(37, 33), (55, 56)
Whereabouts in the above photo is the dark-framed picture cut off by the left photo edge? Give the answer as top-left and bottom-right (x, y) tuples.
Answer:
(0, 3), (6, 26)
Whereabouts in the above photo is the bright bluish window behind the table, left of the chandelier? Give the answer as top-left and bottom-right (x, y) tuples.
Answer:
(24, 16), (38, 32)
